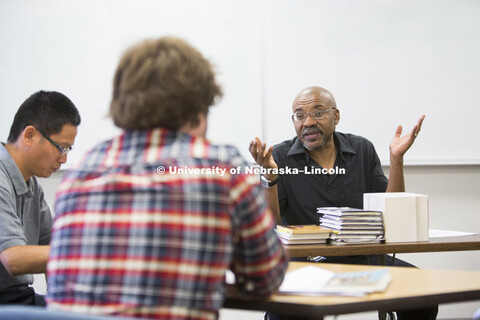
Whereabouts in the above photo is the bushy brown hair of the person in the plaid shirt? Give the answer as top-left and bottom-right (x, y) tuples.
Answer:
(110, 37), (222, 130)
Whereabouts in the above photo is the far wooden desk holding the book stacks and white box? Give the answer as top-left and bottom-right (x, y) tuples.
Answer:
(285, 234), (480, 257)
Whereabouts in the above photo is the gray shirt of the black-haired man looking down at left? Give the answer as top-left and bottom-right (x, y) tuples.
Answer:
(0, 143), (52, 295)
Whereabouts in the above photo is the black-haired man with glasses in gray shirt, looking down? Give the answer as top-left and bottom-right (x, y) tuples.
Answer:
(0, 91), (80, 306)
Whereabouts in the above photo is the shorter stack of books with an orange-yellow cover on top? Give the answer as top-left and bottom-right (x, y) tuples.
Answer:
(275, 225), (332, 245)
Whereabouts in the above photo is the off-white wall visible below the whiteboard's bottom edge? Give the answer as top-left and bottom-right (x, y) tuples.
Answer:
(40, 165), (480, 320)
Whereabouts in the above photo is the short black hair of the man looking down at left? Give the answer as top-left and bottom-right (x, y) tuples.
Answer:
(8, 91), (81, 143)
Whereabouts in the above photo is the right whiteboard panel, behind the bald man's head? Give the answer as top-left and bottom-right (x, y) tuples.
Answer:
(265, 0), (480, 165)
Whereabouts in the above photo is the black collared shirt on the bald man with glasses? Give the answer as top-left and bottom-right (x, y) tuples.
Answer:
(273, 132), (388, 224)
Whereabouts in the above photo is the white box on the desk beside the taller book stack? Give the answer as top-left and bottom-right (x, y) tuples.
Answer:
(363, 192), (429, 242)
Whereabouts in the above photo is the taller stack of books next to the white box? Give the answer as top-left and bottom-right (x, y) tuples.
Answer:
(317, 207), (385, 245)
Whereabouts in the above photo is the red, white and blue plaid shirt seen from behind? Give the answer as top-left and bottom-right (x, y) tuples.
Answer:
(47, 129), (288, 320)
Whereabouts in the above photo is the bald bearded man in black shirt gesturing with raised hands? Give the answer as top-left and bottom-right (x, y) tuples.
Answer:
(250, 87), (437, 320)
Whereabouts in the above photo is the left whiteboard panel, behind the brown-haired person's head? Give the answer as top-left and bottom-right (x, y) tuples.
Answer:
(0, 0), (263, 163)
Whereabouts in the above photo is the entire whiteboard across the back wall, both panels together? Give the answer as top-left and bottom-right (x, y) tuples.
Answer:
(0, 0), (480, 165)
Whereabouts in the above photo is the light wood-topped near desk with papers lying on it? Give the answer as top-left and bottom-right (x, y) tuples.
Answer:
(224, 262), (480, 318)
